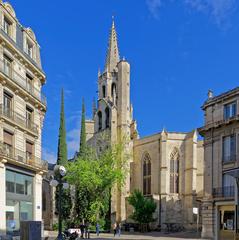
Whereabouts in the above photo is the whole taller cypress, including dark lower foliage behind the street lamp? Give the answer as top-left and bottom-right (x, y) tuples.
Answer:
(55, 89), (72, 225)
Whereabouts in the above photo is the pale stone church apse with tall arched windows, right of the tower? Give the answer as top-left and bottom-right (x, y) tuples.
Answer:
(132, 130), (203, 229)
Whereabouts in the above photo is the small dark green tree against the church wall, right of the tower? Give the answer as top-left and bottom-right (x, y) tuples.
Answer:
(128, 190), (157, 224)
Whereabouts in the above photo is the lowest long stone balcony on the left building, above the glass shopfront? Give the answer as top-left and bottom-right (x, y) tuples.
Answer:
(0, 142), (48, 171)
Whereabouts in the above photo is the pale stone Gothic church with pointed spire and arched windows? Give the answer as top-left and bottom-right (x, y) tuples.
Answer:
(86, 21), (204, 229)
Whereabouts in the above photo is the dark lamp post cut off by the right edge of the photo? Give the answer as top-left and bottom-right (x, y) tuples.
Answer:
(224, 168), (239, 240)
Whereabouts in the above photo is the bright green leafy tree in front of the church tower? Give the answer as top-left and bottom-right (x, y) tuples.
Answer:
(67, 139), (127, 227)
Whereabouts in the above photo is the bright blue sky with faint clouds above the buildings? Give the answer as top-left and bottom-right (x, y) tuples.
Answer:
(8, 0), (239, 162)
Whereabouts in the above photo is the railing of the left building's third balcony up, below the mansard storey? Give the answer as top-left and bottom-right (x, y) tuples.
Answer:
(0, 57), (46, 106)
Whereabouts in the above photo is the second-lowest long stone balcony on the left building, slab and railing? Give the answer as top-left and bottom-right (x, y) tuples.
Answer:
(0, 104), (38, 136)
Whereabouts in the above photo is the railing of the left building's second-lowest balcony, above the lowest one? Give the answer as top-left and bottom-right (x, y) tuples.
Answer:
(0, 104), (38, 134)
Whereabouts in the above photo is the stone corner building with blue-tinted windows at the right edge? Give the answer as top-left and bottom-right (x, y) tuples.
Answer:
(199, 88), (239, 239)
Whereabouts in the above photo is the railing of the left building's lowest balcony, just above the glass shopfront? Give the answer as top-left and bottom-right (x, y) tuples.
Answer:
(0, 142), (48, 170)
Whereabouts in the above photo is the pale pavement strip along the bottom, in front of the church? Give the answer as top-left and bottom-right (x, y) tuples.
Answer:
(49, 232), (204, 240)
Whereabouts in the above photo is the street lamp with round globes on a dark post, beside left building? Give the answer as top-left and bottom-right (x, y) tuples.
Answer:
(50, 165), (69, 240)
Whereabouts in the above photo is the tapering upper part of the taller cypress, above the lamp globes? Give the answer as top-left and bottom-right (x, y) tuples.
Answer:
(57, 89), (67, 166)
